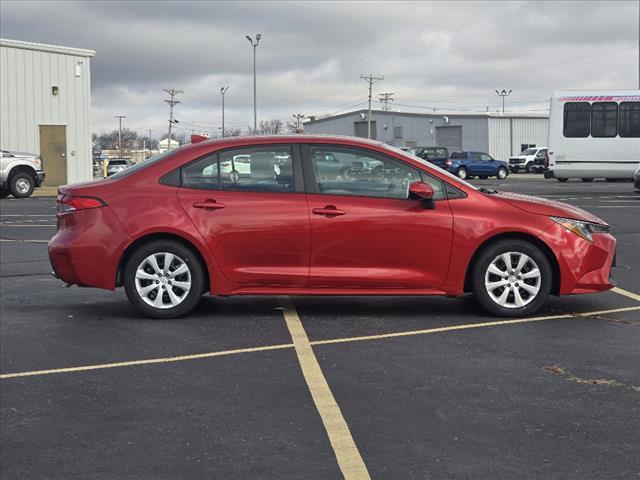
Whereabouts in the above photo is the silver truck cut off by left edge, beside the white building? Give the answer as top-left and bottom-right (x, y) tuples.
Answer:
(0, 150), (44, 198)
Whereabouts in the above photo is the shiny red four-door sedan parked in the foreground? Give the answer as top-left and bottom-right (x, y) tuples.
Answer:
(49, 135), (616, 318)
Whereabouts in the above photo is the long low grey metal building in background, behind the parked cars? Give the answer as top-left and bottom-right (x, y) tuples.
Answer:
(304, 110), (549, 160)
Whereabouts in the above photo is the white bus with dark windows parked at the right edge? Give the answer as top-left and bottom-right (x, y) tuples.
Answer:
(545, 90), (640, 182)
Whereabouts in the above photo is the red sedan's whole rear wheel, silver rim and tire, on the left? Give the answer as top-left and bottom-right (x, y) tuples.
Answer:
(124, 240), (205, 318)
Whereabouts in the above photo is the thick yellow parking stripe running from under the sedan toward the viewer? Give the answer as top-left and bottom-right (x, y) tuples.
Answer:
(282, 299), (371, 480)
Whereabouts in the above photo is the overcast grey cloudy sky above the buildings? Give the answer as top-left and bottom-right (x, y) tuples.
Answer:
(0, 0), (639, 138)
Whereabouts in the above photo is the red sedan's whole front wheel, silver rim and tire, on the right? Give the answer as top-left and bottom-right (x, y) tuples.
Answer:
(472, 239), (553, 317)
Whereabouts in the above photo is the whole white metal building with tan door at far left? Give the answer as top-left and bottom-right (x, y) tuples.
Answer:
(0, 39), (95, 185)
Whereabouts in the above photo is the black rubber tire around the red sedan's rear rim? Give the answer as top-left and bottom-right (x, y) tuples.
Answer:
(124, 240), (205, 318)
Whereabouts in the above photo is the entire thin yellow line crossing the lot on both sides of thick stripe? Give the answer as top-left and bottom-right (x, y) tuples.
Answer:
(0, 307), (640, 380)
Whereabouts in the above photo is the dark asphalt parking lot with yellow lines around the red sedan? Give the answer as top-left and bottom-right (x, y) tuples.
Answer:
(0, 177), (640, 480)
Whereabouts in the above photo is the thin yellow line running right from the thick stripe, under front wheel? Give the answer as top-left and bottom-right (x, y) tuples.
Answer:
(311, 307), (640, 345)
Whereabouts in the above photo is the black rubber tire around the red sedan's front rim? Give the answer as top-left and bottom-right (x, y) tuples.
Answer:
(472, 239), (553, 317)
